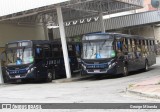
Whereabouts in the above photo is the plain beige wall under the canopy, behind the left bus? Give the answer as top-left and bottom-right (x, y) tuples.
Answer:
(0, 23), (45, 47)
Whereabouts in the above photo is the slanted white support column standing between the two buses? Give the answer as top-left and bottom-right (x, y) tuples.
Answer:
(56, 6), (71, 78)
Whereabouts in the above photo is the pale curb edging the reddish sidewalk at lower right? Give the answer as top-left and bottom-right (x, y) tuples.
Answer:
(126, 88), (160, 100)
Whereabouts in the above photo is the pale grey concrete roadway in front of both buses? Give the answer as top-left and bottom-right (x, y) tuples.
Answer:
(0, 57), (160, 103)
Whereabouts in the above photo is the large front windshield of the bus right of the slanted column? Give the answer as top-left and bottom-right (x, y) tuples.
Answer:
(82, 40), (115, 59)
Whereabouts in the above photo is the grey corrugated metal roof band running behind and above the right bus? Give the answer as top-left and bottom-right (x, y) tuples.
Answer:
(54, 11), (160, 37)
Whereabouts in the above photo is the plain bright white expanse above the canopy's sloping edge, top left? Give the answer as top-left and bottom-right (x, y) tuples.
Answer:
(0, 0), (70, 16)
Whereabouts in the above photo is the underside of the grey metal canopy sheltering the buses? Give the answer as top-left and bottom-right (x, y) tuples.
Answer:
(0, 0), (143, 24)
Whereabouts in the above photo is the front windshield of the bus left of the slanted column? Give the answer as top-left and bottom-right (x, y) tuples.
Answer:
(6, 47), (33, 65)
